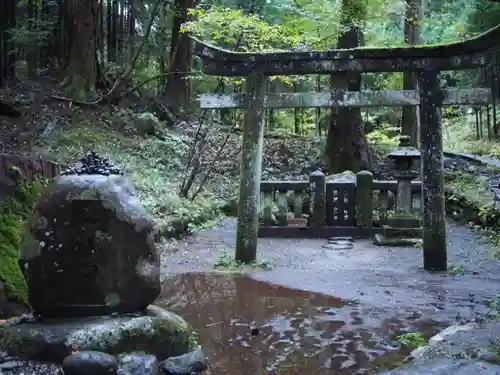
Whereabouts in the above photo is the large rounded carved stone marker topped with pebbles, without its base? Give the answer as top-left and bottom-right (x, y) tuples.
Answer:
(20, 153), (160, 317)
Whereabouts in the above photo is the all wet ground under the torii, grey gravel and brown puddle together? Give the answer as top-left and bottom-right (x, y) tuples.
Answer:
(158, 222), (500, 375)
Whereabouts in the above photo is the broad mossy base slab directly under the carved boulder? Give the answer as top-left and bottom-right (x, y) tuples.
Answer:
(0, 306), (190, 363)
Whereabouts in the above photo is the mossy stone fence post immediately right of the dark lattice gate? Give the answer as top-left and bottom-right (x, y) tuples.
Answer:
(356, 171), (373, 235)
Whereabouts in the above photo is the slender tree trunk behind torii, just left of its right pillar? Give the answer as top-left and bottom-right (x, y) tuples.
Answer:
(401, 0), (422, 147)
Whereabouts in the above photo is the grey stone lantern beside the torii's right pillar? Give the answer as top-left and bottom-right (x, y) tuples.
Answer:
(375, 136), (422, 246)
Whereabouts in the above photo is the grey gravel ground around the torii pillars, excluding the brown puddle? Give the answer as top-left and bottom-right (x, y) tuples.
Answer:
(162, 221), (500, 322)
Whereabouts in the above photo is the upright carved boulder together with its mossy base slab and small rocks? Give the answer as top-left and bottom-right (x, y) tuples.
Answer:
(0, 152), (205, 375)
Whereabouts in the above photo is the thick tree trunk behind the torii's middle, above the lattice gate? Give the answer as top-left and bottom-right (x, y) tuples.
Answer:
(325, 0), (371, 173)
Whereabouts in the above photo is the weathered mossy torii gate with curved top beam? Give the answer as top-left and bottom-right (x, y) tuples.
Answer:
(189, 25), (500, 271)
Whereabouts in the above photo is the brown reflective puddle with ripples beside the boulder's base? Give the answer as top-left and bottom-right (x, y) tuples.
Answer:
(157, 273), (446, 375)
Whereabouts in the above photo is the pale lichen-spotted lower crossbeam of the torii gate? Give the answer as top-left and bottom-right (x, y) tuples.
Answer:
(198, 88), (492, 109)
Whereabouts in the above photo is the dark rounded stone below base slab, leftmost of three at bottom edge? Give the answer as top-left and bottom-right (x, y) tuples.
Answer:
(62, 351), (118, 375)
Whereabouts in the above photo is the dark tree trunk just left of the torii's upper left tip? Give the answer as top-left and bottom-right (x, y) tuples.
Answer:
(165, 0), (196, 115)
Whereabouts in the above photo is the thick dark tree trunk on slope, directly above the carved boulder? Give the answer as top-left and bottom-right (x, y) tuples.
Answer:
(64, 0), (98, 101)
